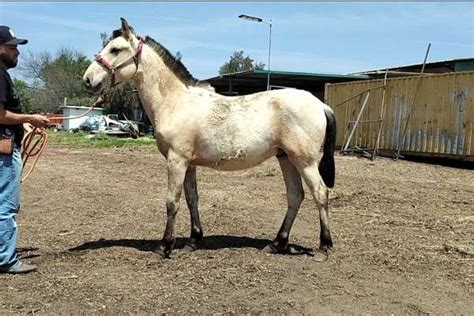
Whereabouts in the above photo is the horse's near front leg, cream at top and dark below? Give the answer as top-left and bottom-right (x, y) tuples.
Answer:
(158, 150), (187, 258)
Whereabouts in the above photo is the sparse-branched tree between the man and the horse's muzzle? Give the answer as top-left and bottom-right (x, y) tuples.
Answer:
(20, 48), (93, 112)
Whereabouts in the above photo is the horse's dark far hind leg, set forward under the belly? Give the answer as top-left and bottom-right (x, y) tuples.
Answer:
(265, 155), (304, 252)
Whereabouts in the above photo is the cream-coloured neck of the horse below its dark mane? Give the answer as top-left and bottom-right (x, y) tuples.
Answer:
(135, 46), (186, 123)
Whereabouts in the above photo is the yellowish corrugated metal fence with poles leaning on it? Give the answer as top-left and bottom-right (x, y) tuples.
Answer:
(325, 72), (474, 160)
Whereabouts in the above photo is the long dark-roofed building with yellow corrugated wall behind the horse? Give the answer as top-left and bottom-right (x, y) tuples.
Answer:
(206, 58), (474, 161)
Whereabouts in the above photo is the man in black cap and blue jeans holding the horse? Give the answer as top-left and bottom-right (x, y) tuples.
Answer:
(0, 25), (49, 273)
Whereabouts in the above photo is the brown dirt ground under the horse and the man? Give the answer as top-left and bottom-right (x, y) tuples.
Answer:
(0, 148), (474, 315)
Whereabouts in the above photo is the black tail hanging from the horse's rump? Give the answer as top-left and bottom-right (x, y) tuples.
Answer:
(318, 109), (336, 188)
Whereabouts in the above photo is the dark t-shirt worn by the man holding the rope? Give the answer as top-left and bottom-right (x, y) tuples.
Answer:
(0, 67), (23, 146)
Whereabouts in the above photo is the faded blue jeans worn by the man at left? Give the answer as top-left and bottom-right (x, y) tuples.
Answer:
(0, 146), (22, 270)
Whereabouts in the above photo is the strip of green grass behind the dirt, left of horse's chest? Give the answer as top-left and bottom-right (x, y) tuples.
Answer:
(48, 131), (156, 148)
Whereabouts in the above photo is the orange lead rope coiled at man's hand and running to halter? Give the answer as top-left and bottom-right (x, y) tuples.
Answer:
(21, 96), (105, 182)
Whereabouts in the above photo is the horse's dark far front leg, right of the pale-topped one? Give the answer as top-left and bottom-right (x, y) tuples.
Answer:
(184, 166), (203, 251)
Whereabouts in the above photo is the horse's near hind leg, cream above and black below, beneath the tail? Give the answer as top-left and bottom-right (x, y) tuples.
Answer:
(301, 164), (332, 260)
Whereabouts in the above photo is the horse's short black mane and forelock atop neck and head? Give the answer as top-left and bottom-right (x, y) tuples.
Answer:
(109, 27), (210, 88)
